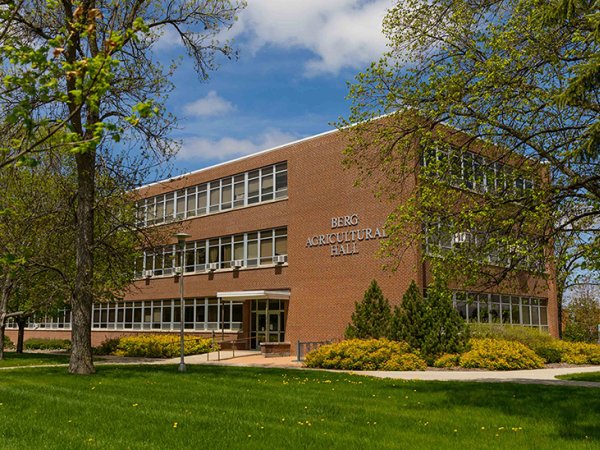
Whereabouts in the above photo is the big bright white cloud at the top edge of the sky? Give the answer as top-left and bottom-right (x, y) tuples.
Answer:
(227, 0), (393, 75)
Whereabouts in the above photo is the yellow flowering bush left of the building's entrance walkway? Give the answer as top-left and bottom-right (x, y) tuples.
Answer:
(114, 334), (218, 358)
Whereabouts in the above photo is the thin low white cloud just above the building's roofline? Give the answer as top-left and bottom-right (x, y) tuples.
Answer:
(177, 129), (297, 162)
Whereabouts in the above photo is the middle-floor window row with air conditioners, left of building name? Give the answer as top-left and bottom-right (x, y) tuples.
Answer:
(135, 227), (287, 278)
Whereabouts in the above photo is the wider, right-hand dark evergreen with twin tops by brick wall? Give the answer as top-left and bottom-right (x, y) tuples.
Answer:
(390, 281), (468, 362)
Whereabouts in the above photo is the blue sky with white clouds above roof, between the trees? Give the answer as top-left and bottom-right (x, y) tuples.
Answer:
(154, 0), (392, 175)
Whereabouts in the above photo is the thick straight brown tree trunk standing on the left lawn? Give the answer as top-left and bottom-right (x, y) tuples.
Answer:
(69, 150), (96, 375)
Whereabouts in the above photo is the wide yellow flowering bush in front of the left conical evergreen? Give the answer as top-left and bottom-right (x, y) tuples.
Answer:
(304, 339), (427, 370)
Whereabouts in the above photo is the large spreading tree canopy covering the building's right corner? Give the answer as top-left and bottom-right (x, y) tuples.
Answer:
(340, 0), (600, 298)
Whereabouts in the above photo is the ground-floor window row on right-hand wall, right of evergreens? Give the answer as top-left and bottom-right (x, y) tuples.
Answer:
(453, 292), (548, 331)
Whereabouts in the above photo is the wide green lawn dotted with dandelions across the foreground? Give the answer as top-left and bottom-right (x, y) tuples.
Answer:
(0, 366), (600, 450)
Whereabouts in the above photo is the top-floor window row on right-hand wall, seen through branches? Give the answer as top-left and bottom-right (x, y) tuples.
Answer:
(422, 148), (534, 195)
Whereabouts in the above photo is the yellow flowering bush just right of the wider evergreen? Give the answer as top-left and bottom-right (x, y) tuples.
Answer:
(460, 338), (544, 370)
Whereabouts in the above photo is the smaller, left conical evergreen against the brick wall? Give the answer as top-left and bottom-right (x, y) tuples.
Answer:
(345, 280), (391, 339)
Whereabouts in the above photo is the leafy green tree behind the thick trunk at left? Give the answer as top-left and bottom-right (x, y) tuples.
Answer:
(0, 152), (142, 358)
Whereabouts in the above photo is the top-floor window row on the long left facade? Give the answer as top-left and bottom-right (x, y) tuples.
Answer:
(136, 162), (288, 227)
